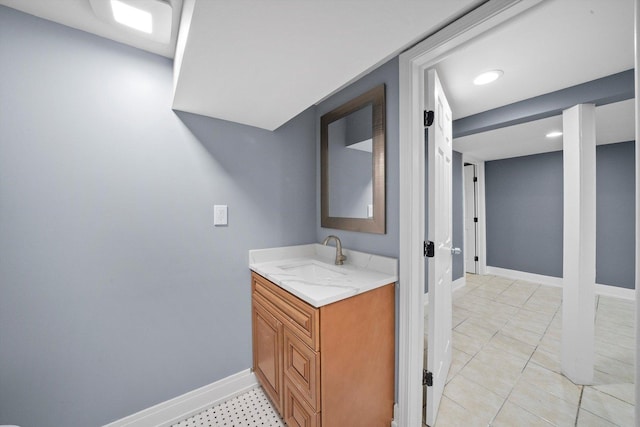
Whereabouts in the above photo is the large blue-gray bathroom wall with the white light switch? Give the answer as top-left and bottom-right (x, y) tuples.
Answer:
(0, 6), (318, 427)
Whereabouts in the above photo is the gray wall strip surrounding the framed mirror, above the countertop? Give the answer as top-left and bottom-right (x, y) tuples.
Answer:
(316, 58), (400, 258)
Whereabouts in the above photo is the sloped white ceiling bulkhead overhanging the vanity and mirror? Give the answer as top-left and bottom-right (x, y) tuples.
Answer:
(173, 0), (480, 129)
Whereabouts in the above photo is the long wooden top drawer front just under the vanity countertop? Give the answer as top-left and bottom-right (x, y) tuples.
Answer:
(251, 273), (320, 351)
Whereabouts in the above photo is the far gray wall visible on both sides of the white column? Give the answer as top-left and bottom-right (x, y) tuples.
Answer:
(485, 142), (635, 289)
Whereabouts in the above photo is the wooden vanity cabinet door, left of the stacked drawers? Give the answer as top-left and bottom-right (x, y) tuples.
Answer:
(253, 301), (283, 415)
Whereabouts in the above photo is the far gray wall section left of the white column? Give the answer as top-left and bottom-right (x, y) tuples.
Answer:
(485, 151), (563, 277)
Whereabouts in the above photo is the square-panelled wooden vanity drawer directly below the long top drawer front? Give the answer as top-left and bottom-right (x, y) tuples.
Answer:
(283, 328), (320, 411)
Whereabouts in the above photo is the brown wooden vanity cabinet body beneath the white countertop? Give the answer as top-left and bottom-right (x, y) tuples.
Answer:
(251, 272), (395, 427)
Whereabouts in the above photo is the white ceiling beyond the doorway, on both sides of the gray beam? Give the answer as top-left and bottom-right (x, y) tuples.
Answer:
(436, 0), (635, 160)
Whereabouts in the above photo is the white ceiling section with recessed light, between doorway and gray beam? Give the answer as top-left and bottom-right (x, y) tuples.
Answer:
(436, 0), (634, 119)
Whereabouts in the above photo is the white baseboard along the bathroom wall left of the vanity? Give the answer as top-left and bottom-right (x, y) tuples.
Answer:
(103, 369), (258, 427)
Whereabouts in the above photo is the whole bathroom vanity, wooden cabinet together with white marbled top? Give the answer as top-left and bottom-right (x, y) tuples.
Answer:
(250, 244), (397, 427)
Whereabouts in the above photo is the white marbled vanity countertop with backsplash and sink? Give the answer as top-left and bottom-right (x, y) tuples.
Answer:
(249, 243), (398, 307)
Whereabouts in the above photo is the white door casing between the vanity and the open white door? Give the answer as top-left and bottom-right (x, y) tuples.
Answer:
(392, 0), (542, 427)
